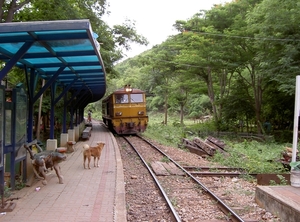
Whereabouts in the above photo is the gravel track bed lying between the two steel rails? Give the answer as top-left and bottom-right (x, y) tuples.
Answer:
(121, 136), (244, 221)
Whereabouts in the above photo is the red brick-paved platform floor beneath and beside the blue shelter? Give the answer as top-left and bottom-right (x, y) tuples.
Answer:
(0, 122), (127, 222)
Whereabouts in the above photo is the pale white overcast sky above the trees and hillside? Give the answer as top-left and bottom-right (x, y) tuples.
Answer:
(103, 0), (228, 57)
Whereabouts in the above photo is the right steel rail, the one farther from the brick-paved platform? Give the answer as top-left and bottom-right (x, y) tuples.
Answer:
(136, 135), (244, 222)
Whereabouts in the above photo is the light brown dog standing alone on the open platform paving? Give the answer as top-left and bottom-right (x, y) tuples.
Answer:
(83, 142), (105, 169)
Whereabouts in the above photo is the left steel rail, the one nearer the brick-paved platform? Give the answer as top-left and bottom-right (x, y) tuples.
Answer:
(122, 136), (181, 222)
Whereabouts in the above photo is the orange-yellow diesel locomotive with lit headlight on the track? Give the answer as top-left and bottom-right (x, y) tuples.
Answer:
(102, 86), (148, 134)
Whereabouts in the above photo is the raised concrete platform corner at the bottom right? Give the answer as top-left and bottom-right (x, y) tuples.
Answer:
(255, 186), (300, 222)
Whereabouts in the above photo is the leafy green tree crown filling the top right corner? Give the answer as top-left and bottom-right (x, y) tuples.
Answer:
(247, 0), (300, 95)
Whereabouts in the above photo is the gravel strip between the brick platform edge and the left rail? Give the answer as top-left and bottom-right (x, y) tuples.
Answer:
(116, 137), (181, 222)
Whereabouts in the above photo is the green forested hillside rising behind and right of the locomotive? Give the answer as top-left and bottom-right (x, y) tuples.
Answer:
(109, 0), (300, 138)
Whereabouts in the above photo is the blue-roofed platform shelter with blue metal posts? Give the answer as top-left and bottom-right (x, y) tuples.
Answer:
(0, 19), (106, 192)
